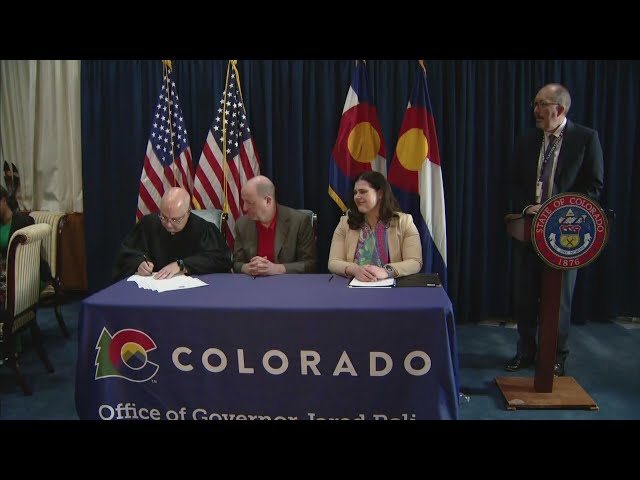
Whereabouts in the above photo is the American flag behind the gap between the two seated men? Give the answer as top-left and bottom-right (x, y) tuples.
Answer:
(193, 60), (260, 251)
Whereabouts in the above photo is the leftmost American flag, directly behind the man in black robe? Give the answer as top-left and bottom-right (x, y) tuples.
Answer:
(136, 60), (194, 220)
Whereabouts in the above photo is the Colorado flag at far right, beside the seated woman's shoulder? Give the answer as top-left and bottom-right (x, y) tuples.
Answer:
(388, 60), (447, 288)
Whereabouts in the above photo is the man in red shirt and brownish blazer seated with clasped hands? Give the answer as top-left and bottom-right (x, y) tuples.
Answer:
(233, 175), (317, 277)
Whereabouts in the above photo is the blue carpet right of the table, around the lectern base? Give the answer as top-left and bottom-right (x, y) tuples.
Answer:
(457, 323), (640, 420)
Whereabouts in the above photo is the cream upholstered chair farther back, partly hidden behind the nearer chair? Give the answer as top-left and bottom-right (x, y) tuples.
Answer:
(29, 210), (69, 338)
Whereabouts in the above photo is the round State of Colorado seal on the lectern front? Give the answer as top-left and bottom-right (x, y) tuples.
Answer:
(531, 193), (609, 270)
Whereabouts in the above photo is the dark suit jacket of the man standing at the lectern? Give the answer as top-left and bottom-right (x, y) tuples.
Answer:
(511, 119), (604, 213)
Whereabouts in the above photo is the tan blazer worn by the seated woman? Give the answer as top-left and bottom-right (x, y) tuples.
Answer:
(329, 212), (422, 277)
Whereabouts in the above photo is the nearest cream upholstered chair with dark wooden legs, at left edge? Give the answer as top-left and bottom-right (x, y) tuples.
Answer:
(2, 223), (54, 395)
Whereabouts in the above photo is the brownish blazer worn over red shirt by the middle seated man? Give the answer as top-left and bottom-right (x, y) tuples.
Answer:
(233, 204), (318, 273)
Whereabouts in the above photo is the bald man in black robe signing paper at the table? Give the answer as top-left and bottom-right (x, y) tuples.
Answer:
(113, 187), (232, 281)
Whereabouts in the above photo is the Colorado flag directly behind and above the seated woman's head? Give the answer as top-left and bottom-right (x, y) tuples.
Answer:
(329, 60), (387, 212)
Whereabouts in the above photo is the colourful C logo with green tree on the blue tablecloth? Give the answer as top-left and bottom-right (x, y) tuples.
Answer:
(96, 328), (160, 382)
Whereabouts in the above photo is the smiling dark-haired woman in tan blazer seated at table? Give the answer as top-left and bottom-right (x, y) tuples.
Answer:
(329, 170), (422, 282)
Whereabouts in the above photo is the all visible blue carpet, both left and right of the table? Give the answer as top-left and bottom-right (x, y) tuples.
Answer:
(0, 301), (640, 420)
